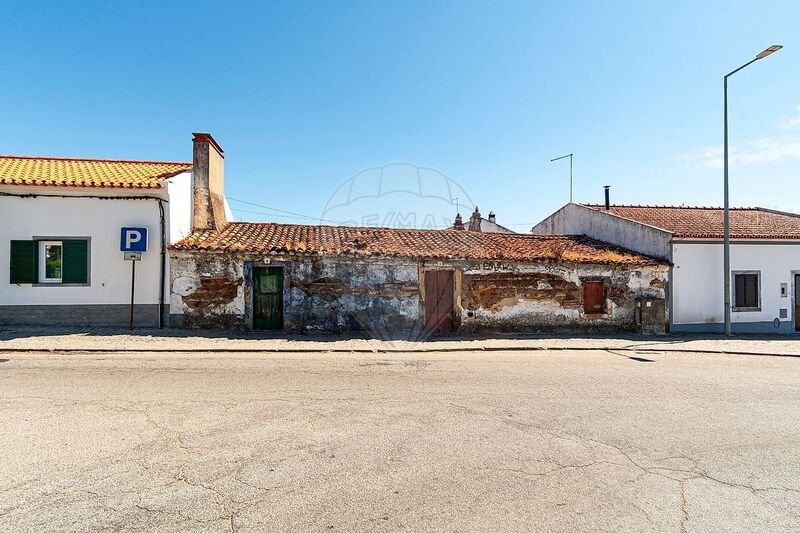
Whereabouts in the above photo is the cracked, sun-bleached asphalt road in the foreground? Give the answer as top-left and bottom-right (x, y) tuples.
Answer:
(0, 351), (800, 532)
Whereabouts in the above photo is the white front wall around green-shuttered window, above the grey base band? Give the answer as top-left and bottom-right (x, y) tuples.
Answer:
(0, 187), (169, 305)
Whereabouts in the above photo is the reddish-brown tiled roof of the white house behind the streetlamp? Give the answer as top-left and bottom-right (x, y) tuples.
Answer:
(586, 204), (800, 239)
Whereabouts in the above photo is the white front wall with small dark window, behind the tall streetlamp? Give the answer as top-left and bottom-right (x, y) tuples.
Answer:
(672, 242), (800, 324)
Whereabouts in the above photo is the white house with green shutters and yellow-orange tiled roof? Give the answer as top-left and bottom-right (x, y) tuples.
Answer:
(0, 134), (228, 327)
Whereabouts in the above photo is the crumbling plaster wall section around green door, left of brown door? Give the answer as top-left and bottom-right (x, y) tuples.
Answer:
(170, 250), (420, 332)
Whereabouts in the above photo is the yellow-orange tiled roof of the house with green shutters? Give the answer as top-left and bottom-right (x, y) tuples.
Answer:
(0, 155), (192, 189)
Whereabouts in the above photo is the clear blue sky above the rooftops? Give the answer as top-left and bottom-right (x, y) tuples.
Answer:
(0, 1), (800, 231)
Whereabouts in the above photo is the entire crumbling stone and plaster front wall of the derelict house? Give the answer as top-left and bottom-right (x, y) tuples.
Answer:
(170, 251), (668, 332)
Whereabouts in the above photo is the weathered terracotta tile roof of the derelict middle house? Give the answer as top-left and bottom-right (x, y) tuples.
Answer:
(171, 222), (666, 265)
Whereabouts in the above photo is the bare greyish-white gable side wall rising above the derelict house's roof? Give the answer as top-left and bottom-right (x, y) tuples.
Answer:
(531, 204), (672, 259)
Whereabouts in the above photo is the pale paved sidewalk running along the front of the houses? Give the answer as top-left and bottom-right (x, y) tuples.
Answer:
(0, 328), (800, 357)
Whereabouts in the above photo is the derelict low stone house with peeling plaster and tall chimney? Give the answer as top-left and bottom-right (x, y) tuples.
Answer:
(169, 134), (669, 337)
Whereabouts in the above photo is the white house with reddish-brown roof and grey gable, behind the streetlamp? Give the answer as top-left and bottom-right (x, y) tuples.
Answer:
(532, 203), (800, 333)
